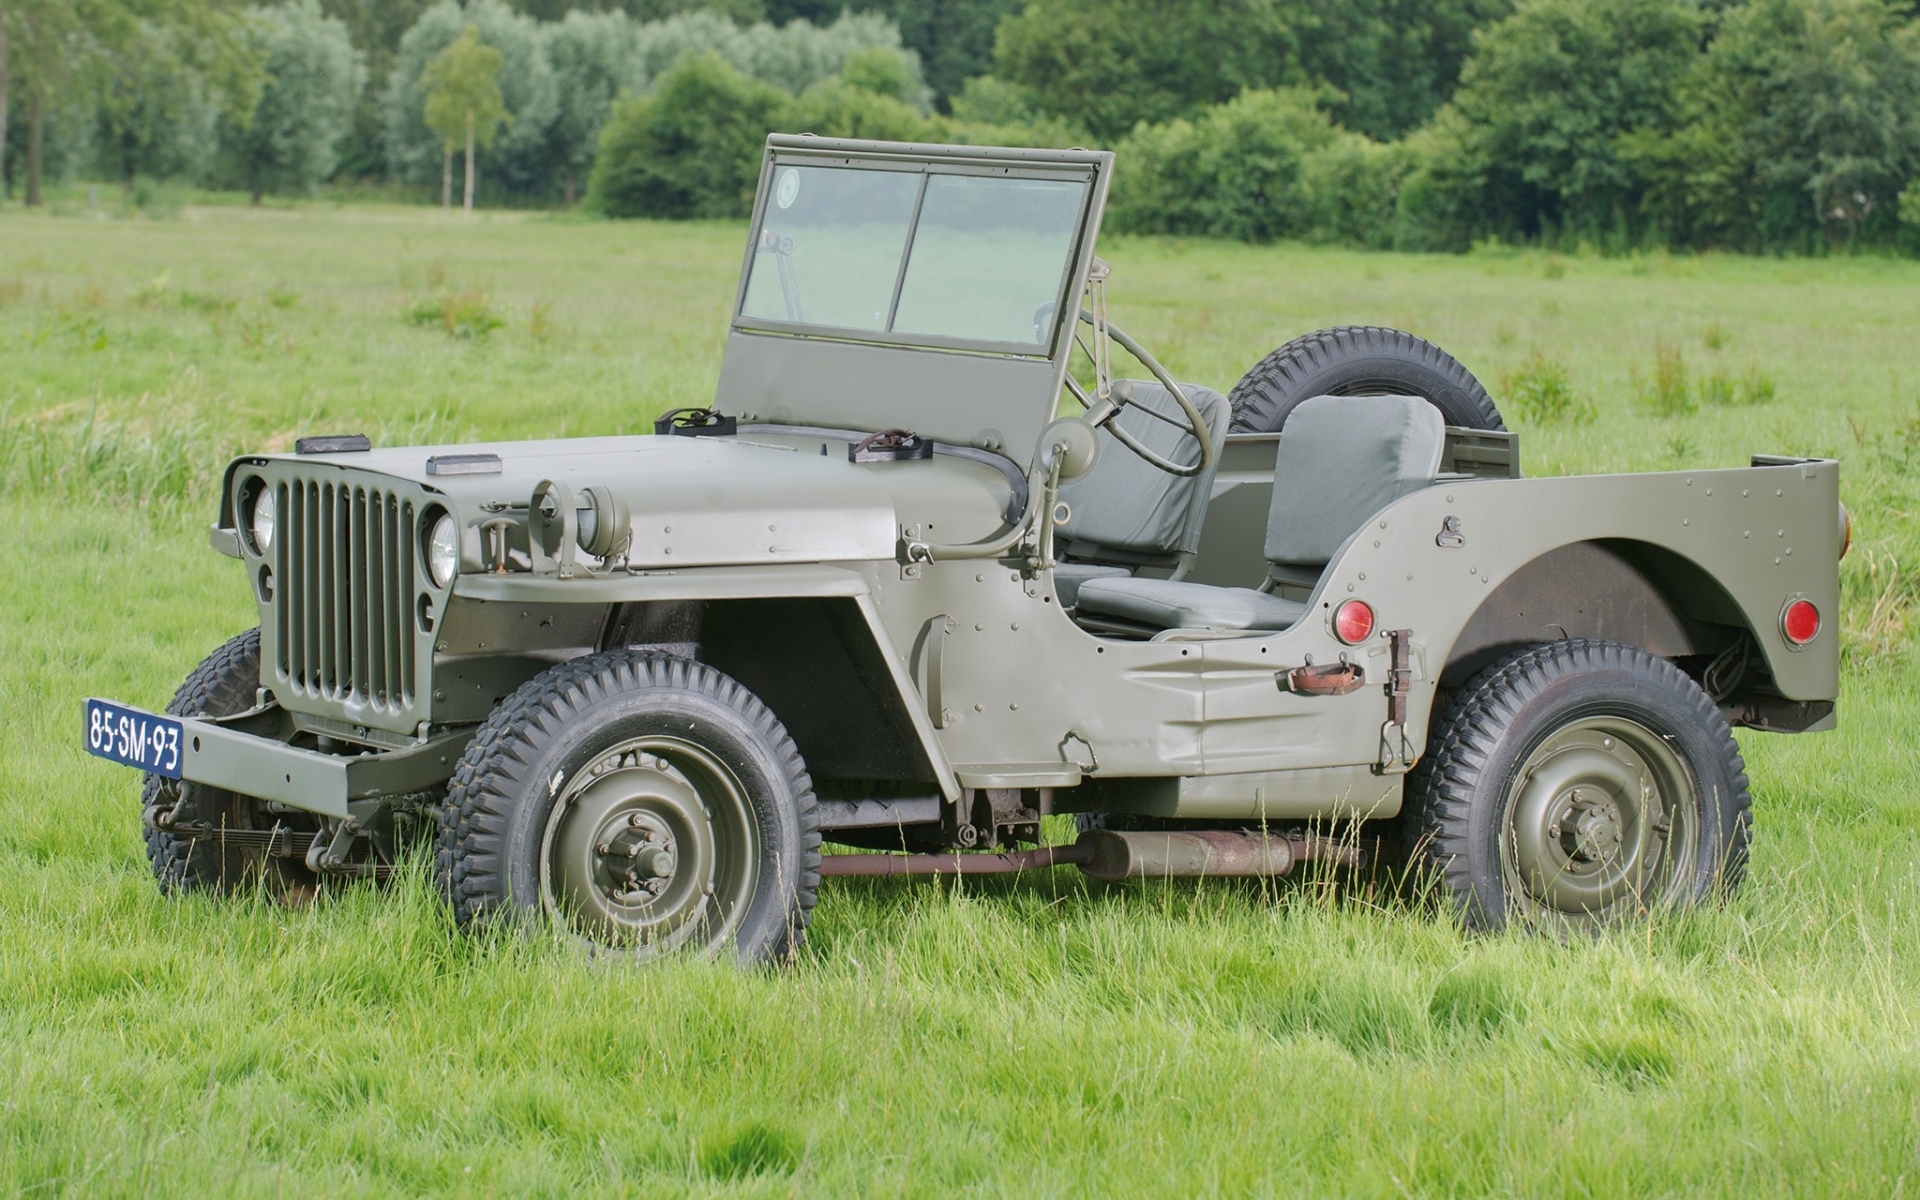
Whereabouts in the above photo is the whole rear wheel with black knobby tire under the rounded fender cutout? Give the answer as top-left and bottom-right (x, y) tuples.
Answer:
(1402, 639), (1753, 931)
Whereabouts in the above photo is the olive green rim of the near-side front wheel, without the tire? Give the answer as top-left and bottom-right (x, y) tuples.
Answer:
(540, 737), (760, 958)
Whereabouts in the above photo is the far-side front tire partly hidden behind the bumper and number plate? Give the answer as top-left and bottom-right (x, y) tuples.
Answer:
(140, 630), (315, 899)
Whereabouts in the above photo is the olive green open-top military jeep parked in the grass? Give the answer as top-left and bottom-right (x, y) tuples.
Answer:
(86, 136), (1845, 962)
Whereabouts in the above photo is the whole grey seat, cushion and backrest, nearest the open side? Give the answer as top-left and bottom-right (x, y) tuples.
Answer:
(1073, 396), (1446, 637)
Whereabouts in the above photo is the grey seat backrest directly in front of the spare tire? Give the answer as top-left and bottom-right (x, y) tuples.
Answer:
(1267, 387), (1446, 566)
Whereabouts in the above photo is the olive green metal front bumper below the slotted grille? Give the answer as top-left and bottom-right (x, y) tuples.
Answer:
(83, 705), (474, 818)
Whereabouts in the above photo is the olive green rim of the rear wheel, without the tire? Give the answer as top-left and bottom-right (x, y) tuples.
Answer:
(1500, 716), (1699, 920)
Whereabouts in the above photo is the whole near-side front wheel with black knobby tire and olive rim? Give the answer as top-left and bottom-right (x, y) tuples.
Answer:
(436, 651), (820, 964)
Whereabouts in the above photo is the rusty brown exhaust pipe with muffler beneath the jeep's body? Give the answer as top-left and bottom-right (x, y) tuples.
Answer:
(820, 829), (1361, 879)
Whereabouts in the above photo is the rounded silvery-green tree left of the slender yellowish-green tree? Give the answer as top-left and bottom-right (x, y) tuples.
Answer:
(219, 0), (367, 204)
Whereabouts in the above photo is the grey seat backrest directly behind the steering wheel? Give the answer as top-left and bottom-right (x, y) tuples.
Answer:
(1060, 380), (1233, 559)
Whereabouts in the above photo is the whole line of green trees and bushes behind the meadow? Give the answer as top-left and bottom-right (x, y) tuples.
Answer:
(0, 0), (1920, 252)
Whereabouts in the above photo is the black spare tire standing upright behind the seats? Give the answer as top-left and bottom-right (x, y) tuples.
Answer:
(1227, 324), (1507, 434)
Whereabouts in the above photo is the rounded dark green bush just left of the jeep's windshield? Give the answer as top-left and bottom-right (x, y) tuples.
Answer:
(588, 52), (791, 217)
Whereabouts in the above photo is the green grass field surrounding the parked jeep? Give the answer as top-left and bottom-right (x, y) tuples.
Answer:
(0, 207), (1920, 1198)
